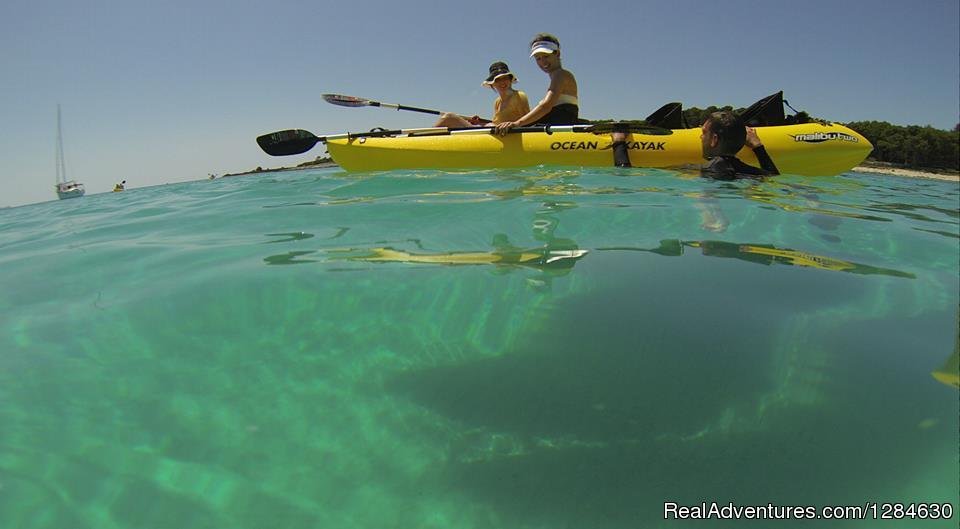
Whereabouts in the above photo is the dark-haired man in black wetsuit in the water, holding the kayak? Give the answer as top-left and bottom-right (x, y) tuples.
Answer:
(611, 110), (780, 180)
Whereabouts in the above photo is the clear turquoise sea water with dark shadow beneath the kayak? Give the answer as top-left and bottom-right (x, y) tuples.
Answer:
(0, 168), (960, 529)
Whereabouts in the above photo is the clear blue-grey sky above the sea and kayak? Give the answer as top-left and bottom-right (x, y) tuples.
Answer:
(0, 0), (960, 207)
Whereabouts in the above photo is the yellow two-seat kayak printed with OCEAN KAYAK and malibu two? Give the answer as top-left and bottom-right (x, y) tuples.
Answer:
(326, 123), (873, 176)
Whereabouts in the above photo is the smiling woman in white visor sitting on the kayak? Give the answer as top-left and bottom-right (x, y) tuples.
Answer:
(496, 33), (580, 135)
